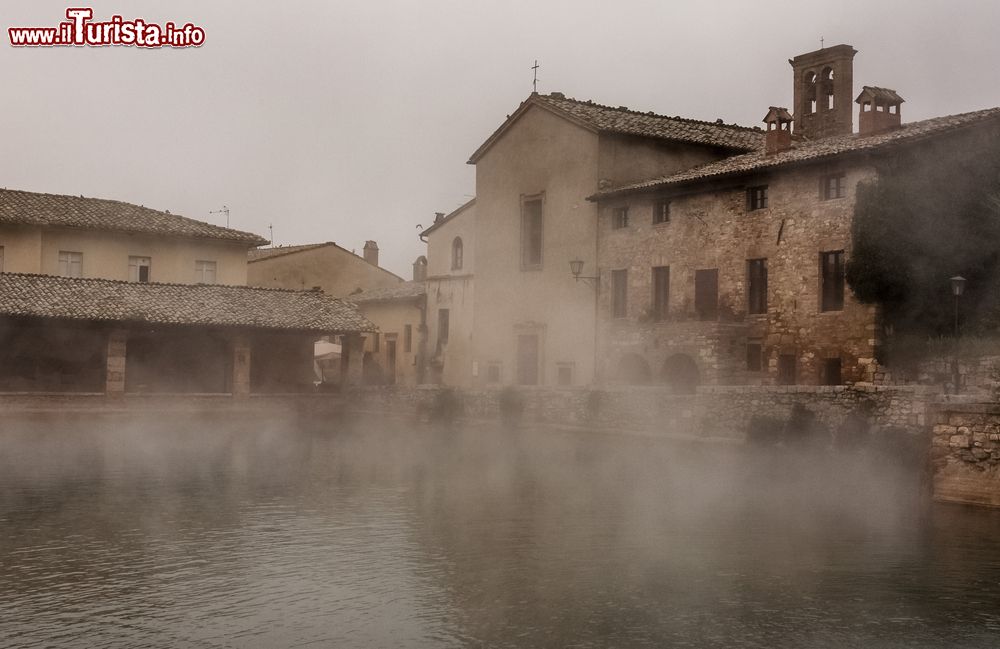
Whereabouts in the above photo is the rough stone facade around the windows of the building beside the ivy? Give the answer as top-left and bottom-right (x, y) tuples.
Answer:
(598, 165), (876, 385)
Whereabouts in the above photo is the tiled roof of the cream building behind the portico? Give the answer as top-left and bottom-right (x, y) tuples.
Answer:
(0, 189), (267, 246)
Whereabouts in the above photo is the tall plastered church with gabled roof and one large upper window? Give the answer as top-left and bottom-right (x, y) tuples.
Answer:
(450, 93), (763, 386)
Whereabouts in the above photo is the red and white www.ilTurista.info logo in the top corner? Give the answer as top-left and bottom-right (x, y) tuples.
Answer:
(7, 7), (205, 48)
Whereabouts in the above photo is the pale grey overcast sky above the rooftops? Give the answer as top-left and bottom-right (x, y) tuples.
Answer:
(0, 0), (1000, 278)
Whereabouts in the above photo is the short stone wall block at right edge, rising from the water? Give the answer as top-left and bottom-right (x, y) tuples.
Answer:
(931, 403), (1000, 507)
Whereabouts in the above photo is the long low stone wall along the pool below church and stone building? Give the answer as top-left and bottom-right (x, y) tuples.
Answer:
(350, 386), (936, 440)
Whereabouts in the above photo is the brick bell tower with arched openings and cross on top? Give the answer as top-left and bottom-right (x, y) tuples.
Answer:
(788, 45), (857, 140)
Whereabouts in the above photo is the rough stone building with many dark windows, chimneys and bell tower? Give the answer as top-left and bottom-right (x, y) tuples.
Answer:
(591, 45), (1000, 391)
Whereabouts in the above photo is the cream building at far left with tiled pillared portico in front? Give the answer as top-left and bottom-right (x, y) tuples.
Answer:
(0, 190), (375, 396)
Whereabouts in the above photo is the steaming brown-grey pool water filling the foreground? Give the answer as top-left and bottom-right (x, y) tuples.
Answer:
(0, 422), (1000, 648)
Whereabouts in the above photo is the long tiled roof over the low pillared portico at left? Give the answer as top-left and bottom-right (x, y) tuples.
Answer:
(0, 273), (376, 333)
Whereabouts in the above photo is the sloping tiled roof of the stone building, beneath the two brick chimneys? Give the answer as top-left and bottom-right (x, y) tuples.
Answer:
(590, 108), (1000, 200)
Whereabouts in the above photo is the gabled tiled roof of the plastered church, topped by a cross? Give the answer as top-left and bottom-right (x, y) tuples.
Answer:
(469, 93), (764, 163)
